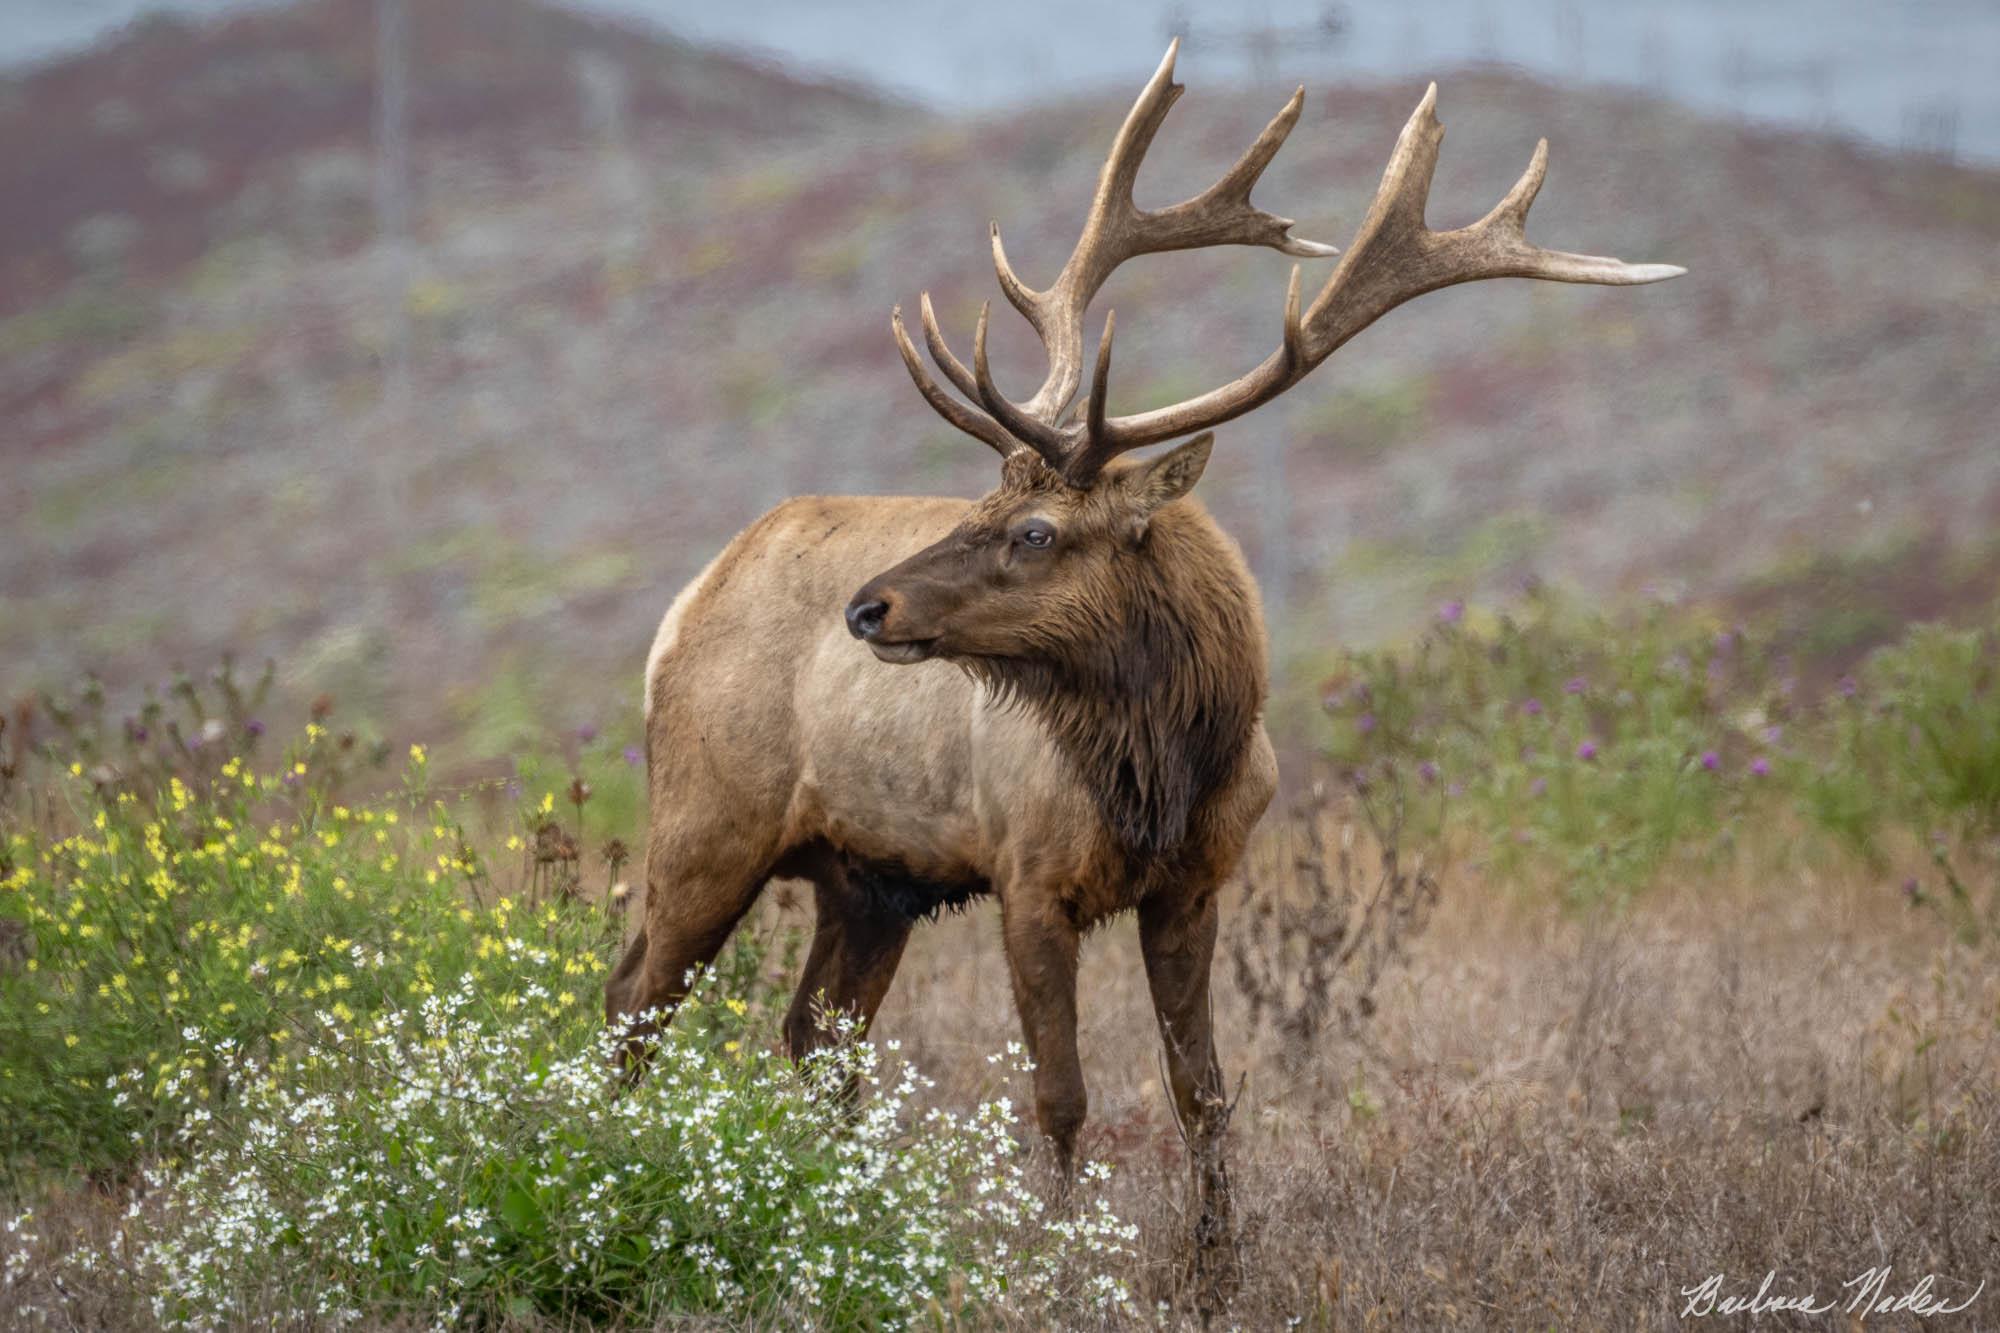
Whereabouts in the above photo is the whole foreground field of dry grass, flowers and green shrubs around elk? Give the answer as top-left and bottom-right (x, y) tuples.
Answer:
(0, 610), (2000, 1329)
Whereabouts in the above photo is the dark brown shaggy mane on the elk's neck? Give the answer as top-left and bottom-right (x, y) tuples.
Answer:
(974, 504), (1264, 857)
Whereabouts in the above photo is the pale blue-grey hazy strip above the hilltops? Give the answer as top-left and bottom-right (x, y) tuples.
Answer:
(0, 0), (2000, 162)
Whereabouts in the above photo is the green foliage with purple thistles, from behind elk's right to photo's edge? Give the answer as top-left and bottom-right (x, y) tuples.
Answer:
(1326, 594), (2000, 912)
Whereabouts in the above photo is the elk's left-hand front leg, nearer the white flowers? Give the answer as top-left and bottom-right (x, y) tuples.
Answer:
(1000, 895), (1090, 1189)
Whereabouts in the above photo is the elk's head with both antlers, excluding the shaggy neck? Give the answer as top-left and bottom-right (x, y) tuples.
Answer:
(846, 38), (1686, 662)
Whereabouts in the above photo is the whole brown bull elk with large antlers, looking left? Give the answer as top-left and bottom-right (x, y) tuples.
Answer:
(606, 44), (1682, 1221)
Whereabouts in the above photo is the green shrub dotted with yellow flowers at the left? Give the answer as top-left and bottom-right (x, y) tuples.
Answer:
(0, 725), (608, 1179)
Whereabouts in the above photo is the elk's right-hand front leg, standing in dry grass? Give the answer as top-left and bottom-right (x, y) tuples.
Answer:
(1138, 880), (1232, 1269)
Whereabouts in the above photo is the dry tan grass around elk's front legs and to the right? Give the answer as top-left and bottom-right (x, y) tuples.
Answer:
(860, 800), (2000, 1329)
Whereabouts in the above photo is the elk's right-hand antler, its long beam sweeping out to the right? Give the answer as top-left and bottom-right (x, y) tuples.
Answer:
(1094, 84), (1686, 456)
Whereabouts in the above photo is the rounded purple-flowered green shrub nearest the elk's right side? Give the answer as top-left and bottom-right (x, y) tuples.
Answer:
(1326, 596), (1788, 901)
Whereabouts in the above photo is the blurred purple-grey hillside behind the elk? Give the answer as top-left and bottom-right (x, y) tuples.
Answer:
(0, 0), (2000, 755)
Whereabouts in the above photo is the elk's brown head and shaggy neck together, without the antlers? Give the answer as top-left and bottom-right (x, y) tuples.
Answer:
(848, 436), (1264, 863)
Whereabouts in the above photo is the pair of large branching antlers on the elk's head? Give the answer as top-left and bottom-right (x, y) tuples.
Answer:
(890, 38), (1686, 486)
